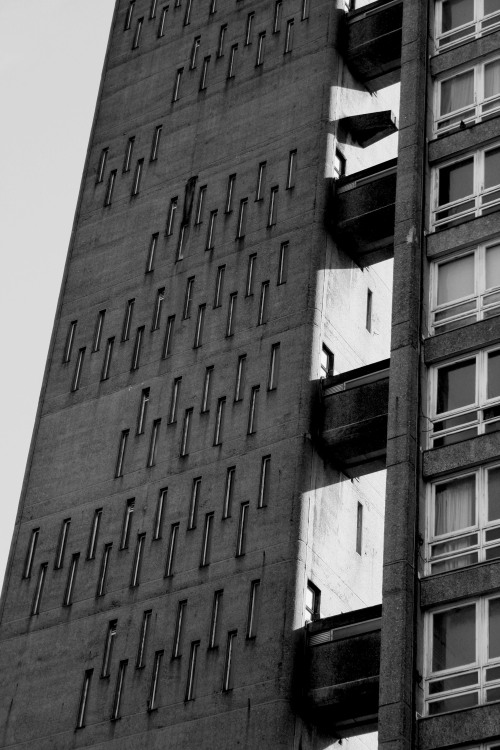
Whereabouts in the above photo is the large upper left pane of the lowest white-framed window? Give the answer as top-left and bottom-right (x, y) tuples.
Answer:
(432, 604), (476, 672)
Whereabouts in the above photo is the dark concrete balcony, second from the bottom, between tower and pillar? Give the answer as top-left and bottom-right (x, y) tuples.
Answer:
(321, 359), (390, 477)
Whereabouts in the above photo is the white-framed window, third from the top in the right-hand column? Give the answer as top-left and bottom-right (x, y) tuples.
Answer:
(432, 146), (500, 229)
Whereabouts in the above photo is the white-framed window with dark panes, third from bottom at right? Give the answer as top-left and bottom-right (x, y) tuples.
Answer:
(430, 349), (500, 448)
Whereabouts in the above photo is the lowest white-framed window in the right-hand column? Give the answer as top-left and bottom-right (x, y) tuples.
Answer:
(425, 597), (500, 716)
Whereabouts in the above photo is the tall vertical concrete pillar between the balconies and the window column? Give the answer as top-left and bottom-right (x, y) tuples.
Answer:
(379, 0), (428, 750)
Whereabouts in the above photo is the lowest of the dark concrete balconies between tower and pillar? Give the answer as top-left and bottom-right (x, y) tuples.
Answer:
(306, 605), (382, 737)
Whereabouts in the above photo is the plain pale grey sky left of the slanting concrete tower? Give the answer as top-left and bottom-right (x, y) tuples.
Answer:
(0, 0), (114, 584)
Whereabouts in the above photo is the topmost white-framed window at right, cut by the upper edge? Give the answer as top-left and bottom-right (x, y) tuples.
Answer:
(436, 0), (500, 50)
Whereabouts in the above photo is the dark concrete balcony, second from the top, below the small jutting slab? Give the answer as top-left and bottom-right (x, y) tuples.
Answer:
(327, 159), (397, 265)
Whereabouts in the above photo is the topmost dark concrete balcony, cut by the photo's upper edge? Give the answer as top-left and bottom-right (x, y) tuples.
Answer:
(341, 0), (403, 91)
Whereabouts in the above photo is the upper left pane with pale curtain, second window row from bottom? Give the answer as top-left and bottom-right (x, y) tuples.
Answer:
(434, 474), (476, 536)
